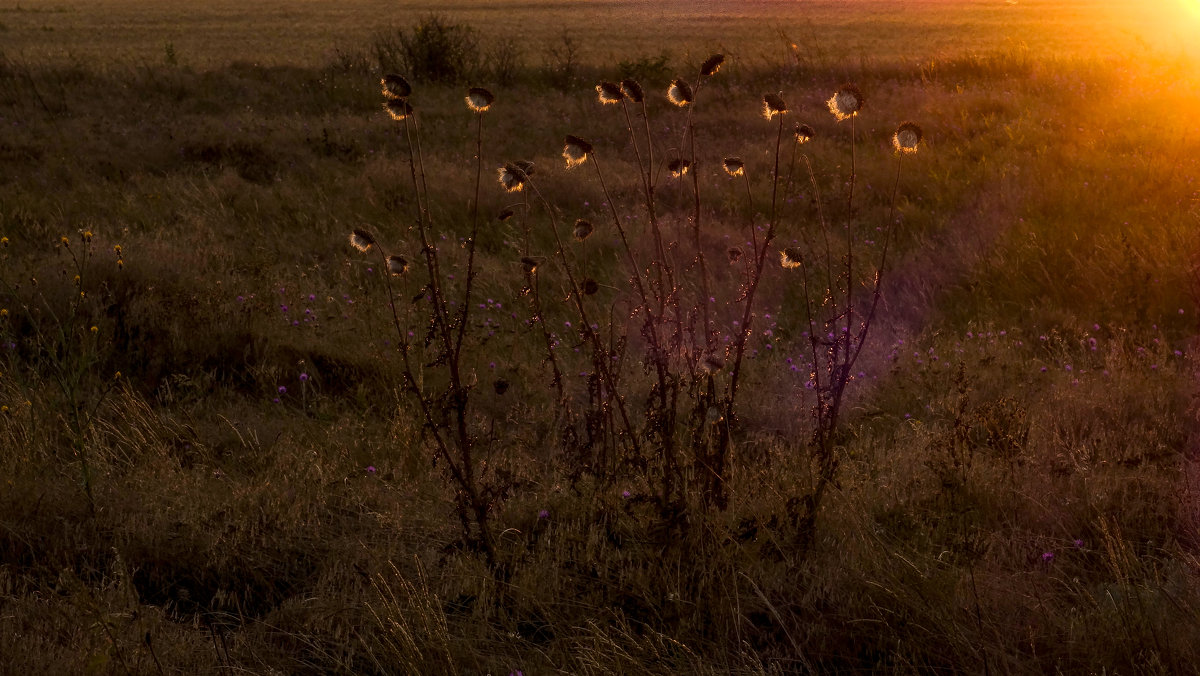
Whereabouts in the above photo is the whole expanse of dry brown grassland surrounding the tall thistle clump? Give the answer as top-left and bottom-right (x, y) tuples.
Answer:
(0, 0), (1200, 675)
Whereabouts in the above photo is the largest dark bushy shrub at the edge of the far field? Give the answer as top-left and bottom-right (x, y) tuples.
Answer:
(372, 14), (480, 83)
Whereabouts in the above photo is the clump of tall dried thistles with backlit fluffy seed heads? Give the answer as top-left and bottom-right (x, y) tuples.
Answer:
(352, 64), (922, 566)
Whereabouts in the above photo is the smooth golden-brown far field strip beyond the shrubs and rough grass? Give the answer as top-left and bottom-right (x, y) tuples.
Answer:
(7, 0), (1200, 67)
